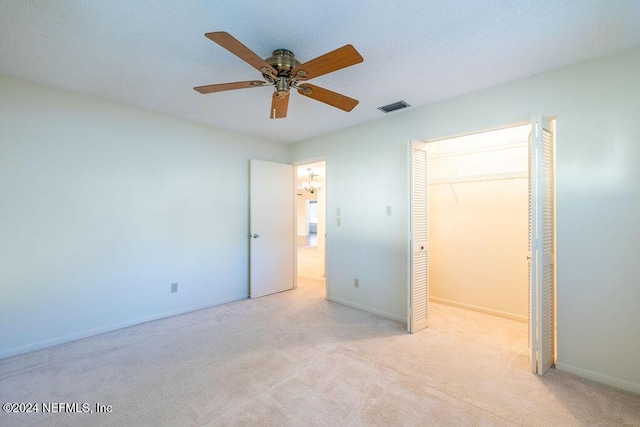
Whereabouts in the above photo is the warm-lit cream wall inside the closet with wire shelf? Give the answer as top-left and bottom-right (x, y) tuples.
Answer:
(427, 125), (529, 321)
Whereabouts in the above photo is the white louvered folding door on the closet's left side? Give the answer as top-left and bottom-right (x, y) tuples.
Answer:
(407, 141), (429, 333)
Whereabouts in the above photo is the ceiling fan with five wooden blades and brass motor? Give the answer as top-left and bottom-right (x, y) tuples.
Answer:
(193, 31), (363, 119)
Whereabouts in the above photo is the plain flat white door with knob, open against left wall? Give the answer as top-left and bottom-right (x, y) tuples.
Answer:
(249, 160), (295, 298)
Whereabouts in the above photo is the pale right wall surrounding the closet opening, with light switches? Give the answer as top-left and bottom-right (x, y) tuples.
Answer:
(293, 49), (640, 392)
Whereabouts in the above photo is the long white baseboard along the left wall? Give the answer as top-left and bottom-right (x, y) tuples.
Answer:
(0, 295), (247, 360)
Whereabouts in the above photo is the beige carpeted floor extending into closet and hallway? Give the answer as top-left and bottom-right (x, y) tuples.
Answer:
(0, 246), (640, 426)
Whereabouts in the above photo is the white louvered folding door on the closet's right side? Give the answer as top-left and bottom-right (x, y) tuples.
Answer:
(528, 116), (556, 375)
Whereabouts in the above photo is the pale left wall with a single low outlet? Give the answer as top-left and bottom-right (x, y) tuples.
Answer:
(0, 76), (289, 358)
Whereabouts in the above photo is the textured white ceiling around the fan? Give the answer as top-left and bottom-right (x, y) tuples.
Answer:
(0, 0), (640, 142)
